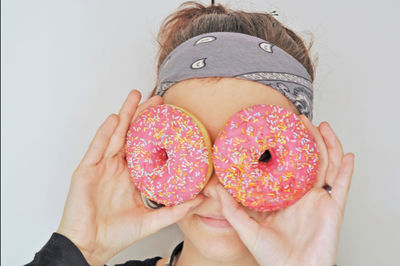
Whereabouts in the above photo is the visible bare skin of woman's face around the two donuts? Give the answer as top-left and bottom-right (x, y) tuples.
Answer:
(163, 77), (299, 261)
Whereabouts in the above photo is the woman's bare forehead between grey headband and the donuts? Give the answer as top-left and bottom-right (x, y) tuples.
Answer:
(163, 78), (299, 142)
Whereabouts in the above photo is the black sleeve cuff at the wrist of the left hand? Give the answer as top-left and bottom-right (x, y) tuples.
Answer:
(25, 232), (90, 266)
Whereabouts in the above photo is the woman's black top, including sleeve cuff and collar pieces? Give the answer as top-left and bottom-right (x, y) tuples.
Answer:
(25, 232), (183, 266)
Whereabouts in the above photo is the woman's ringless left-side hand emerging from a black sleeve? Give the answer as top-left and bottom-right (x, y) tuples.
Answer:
(57, 90), (205, 265)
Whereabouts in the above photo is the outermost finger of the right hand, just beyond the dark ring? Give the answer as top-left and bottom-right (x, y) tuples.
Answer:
(331, 153), (355, 211)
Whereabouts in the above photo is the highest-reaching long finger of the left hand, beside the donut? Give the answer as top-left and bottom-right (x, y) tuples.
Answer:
(104, 90), (142, 157)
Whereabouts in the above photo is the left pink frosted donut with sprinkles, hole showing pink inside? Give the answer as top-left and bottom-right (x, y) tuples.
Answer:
(126, 104), (213, 206)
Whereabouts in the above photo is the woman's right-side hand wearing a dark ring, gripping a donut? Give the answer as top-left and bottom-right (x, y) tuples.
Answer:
(218, 115), (354, 266)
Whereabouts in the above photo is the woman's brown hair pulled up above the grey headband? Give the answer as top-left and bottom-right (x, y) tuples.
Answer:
(148, 1), (314, 98)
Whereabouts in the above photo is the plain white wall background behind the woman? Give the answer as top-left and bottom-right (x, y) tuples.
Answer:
(1, 0), (400, 266)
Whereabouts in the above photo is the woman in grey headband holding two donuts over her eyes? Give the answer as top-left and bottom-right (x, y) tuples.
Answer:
(29, 2), (354, 266)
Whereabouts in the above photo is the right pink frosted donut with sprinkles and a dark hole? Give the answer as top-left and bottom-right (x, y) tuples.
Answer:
(213, 104), (319, 211)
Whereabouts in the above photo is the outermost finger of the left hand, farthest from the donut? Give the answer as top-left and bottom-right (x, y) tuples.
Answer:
(82, 114), (119, 165)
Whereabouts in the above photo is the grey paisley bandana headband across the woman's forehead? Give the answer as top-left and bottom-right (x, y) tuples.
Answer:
(156, 32), (313, 120)
